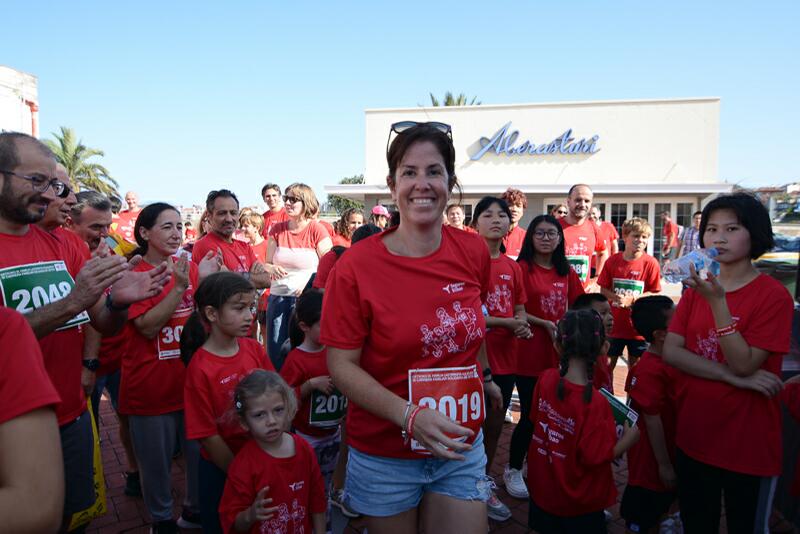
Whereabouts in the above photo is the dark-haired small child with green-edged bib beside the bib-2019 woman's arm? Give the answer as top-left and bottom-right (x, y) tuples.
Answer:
(280, 289), (340, 520)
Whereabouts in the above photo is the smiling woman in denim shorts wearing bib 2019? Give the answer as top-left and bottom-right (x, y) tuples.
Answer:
(320, 122), (502, 534)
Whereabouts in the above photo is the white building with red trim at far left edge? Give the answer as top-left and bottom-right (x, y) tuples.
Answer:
(0, 65), (39, 137)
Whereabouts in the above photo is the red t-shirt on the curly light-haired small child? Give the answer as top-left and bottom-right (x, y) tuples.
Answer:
(219, 435), (328, 534)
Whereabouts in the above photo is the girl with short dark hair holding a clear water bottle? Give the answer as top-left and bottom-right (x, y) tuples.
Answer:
(664, 193), (792, 532)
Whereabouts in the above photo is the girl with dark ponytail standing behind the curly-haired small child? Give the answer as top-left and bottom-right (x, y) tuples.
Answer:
(181, 272), (272, 532)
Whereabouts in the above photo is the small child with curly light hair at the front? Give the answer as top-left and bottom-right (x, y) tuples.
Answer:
(219, 369), (327, 534)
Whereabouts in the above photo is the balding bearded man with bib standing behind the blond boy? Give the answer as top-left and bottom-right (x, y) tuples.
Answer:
(558, 184), (608, 288)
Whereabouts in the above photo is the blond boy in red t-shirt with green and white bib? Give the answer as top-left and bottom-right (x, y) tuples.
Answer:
(597, 218), (661, 372)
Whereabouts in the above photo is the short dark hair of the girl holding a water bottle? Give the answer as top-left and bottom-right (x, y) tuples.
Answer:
(700, 192), (775, 259)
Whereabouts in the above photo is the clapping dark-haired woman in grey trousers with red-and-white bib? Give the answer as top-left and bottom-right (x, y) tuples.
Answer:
(119, 202), (219, 529)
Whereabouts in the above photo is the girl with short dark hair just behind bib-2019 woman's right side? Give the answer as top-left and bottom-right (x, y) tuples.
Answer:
(473, 197), (531, 521)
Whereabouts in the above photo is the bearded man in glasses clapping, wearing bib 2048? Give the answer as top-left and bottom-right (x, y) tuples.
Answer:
(0, 132), (169, 525)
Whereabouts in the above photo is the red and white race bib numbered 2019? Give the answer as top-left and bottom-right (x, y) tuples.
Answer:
(408, 365), (485, 454)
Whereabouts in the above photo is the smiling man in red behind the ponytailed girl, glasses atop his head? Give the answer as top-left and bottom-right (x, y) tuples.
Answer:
(192, 189), (270, 289)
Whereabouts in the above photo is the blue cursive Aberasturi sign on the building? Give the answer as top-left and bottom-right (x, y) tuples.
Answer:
(470, 122), (600, 161)
